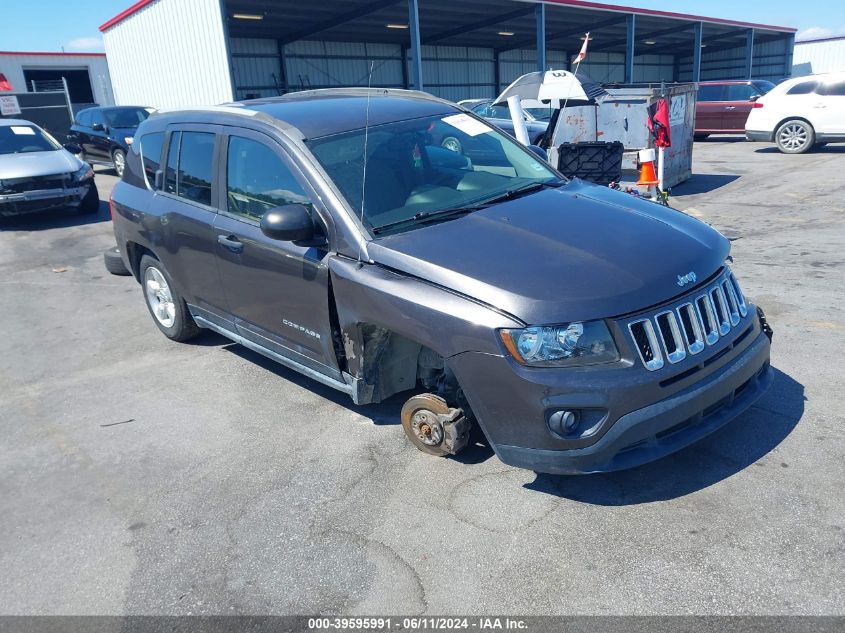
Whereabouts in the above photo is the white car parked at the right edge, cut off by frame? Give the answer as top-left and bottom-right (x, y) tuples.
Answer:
(745, 72), (845, 154)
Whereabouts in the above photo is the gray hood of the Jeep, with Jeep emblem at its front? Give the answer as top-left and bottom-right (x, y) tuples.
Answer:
(368, 180), (730, 325)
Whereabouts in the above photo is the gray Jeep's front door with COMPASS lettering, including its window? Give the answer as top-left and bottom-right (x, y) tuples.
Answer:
(214, 130), (341, 380)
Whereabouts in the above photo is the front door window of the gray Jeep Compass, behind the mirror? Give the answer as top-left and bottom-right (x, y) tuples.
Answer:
(226, 136), (311, 220)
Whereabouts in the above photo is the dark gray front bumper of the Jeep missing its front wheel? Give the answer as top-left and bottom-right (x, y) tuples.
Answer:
(452, 308), (772, 474)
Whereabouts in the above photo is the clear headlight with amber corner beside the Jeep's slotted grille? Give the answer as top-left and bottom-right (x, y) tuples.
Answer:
(499, 321), (619, 367)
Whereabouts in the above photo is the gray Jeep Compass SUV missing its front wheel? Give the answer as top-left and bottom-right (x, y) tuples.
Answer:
(112, 89), (771, 473)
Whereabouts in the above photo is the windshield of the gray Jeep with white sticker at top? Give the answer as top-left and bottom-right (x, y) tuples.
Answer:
(308, 113), (560, 233)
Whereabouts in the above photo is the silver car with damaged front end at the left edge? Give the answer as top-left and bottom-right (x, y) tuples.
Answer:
(0, 119), (100, 217)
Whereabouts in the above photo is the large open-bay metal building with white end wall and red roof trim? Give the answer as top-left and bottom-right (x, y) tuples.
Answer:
(100, 0), (795, 108)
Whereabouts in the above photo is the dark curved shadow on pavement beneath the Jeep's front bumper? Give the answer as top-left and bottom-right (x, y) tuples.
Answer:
(525, 369), (806, 506)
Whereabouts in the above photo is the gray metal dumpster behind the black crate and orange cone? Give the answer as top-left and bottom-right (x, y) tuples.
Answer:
(549, 83), (696, 187)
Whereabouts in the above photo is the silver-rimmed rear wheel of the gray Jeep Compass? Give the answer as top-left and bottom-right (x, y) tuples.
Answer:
(139, 255), (200, 341)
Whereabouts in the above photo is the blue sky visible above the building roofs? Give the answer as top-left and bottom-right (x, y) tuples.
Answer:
(0, 0), (845, 51)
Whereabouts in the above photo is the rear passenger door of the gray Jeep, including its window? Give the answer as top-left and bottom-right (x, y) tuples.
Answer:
(141, 125), (234, 330)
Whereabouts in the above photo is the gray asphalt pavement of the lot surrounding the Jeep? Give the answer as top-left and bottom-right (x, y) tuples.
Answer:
(0, 139), (845, 614)
